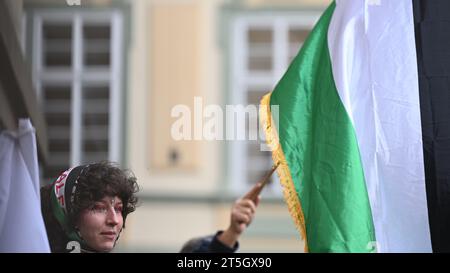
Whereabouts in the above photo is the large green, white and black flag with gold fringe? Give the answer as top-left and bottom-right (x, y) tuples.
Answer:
(261, 0), (450, 252)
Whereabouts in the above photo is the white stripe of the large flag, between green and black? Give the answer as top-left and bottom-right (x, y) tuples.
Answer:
(328, 0), (431, 252)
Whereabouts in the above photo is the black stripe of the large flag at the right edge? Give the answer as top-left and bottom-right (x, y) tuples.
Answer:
(413, 0), (450, 252)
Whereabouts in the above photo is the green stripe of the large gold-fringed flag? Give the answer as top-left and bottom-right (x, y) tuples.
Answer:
(262, 2), (375, 252)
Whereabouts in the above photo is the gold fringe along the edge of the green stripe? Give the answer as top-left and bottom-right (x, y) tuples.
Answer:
(259, 93), (308, 252)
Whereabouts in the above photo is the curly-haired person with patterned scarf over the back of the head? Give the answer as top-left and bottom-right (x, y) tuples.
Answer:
(41, 161), (139, 252)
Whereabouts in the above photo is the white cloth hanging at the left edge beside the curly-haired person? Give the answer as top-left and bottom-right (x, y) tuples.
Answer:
(0, 119), (50, 253)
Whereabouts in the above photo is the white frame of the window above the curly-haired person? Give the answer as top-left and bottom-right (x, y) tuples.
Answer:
(27, 8), (125, 174)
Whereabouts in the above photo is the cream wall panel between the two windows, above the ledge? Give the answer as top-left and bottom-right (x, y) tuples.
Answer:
(127, 0), (221, 194)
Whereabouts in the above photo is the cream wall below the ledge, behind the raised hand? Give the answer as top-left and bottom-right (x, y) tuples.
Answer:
(117, 202), (304, 252)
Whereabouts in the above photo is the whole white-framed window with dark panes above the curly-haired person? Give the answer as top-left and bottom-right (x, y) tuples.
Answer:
(30, 10), (123, 182)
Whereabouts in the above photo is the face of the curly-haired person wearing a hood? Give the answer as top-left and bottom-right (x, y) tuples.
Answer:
(78, 197), (123, 252)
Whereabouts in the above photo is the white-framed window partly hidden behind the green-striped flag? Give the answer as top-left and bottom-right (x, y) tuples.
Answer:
(229, 12), (320, 196)
